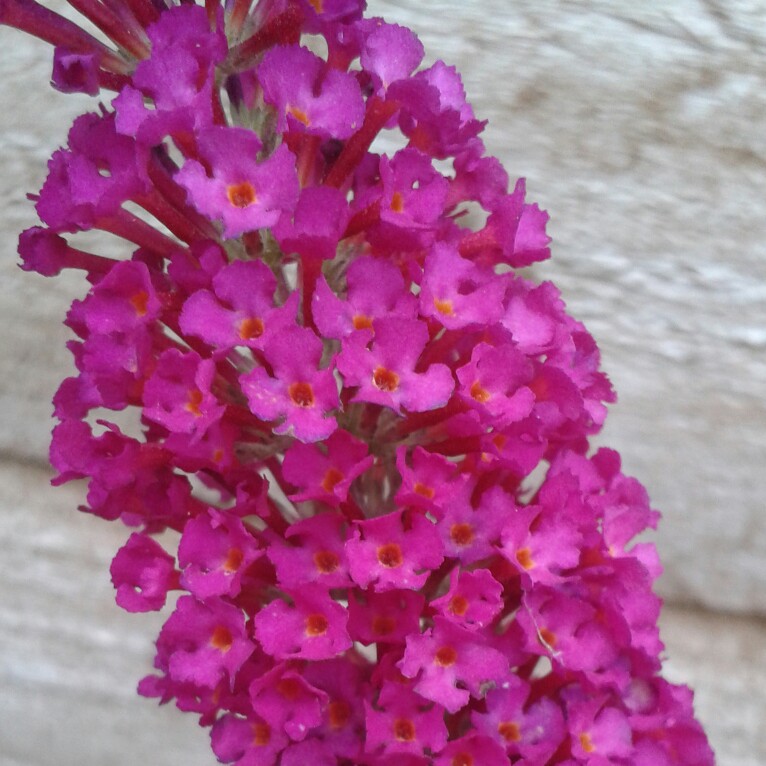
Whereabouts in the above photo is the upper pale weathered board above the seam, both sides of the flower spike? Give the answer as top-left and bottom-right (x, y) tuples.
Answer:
(0, 0), (766, 613)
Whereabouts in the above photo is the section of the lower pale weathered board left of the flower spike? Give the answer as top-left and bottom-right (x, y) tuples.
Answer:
(0, 464), (210, 766)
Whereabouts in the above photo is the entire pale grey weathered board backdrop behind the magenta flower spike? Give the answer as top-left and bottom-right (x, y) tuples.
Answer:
(0, 0), (766, 766)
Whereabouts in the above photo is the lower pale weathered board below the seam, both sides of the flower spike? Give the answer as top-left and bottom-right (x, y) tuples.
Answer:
(0, 465), (766, 766)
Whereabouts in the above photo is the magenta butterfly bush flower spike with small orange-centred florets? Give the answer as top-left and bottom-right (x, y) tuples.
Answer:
(0, 0), (713, 766)
